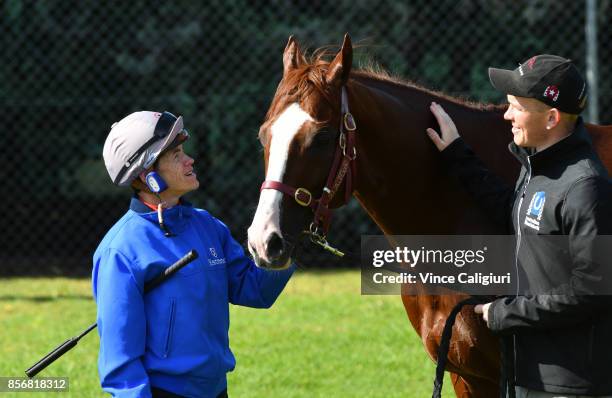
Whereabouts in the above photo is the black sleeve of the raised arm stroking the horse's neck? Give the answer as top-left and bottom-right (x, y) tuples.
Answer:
(441, 138), (514, 231)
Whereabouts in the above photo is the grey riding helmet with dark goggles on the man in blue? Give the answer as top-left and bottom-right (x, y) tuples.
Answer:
(102, 111), (189, 186)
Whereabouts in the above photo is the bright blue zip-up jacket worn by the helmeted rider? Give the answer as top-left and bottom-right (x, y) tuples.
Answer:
(92, 198), (294, 397)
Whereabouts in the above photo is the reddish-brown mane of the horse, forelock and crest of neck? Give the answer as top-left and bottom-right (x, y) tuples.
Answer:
(266, 47), (505, 120)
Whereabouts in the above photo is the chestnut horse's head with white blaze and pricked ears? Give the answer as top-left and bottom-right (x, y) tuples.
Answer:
(248, 35), (353, 268)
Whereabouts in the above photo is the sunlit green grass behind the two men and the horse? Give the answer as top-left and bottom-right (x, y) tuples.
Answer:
(0, 271), (454, 398)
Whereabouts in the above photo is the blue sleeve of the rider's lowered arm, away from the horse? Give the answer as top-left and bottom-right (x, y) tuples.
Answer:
(94, 249), (151, 398)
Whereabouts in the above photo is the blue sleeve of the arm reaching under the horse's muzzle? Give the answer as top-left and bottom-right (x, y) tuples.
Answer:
(213, 218), (295, 308)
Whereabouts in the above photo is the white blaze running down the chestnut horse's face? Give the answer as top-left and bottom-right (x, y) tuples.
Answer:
(249, 103), (314, 262)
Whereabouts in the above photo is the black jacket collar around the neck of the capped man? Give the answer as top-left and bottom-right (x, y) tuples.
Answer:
(508, 117), (592, 170)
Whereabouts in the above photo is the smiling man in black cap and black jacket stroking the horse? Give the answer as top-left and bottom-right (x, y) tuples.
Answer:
(427, 55), (612, 397)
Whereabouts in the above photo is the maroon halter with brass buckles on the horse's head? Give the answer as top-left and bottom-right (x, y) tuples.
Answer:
(260, 86), (357, 257)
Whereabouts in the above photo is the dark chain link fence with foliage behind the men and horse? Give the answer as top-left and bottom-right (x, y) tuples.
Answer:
(0, 0), (612, 275)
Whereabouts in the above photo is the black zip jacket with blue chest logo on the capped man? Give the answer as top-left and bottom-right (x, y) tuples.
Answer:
(442, 119), (612, 395)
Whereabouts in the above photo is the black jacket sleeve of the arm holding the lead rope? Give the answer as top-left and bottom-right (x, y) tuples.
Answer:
(488, 177), (612, 333)
